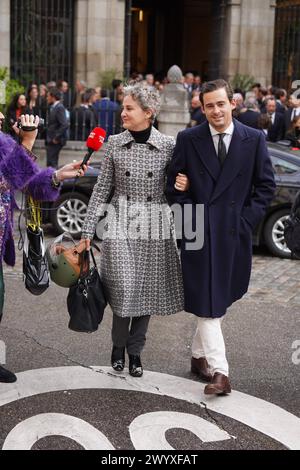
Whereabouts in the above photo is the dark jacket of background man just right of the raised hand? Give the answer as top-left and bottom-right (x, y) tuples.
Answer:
(46, 103), (69, 145)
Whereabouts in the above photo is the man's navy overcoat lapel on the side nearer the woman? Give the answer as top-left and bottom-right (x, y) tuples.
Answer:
(192, 123), (221, 181)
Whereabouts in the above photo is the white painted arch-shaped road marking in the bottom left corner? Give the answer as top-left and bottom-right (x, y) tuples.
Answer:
(2, 413), (115, 450)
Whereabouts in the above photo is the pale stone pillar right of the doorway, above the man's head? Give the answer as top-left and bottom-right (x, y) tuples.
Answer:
(222, 0), (276, 85)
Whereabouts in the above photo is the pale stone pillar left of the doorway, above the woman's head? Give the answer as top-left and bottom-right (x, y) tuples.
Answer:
(75, 0), (125, 86)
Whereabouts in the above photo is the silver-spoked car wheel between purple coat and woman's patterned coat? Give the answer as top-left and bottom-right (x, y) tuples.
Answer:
(51, 192), (89, 238)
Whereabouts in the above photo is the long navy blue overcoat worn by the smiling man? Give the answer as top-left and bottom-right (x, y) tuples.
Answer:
(167, 120), (275, 318)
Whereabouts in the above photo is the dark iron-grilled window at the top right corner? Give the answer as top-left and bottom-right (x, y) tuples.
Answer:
(273, 0), (300, 89)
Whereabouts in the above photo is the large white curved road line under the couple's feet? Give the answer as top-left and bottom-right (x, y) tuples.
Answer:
(0, 366), (300, 450)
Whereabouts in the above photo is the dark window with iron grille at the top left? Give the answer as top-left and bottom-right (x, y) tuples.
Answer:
(10, 0), (75, 85)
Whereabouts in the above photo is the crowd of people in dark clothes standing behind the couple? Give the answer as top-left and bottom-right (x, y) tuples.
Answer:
(6, 72), (300, 158)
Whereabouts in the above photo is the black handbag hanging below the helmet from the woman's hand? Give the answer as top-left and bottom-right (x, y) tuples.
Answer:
(67, 245), (107, 333)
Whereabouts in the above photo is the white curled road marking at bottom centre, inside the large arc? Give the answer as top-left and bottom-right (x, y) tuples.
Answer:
(129, 411), (230, 450)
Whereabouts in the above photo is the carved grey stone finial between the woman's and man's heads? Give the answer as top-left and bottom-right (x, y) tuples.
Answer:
(157, 65), (191, 137)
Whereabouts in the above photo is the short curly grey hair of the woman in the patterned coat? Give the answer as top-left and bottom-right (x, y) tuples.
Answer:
(124, 83), (161, 122)
